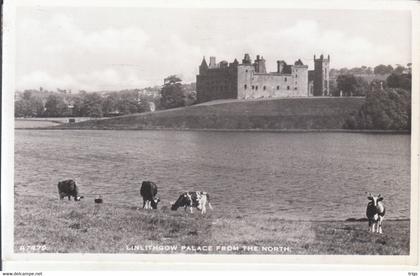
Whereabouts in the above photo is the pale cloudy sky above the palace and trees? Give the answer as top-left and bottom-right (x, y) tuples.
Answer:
(16, 7), (411, 91)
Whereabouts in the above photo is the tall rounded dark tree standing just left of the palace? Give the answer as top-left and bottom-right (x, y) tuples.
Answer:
(160, 75), (187, 109)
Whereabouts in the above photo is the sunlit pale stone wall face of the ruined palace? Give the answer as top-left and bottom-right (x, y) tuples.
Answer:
(238, 65), (308, 99)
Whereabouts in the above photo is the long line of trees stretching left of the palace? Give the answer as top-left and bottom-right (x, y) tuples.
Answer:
(15, 75), (196, 117)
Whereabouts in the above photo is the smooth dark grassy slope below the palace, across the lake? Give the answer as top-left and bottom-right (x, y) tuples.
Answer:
(59, 97), (365, 130)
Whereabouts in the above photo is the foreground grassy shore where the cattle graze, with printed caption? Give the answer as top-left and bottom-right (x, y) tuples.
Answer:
(14, 196), (410, 255)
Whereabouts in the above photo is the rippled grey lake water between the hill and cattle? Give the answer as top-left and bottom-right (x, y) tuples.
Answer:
(15, 130), (410, 220)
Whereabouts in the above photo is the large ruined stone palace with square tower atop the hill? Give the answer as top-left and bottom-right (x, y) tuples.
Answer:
(197, 54), (329, 103)
